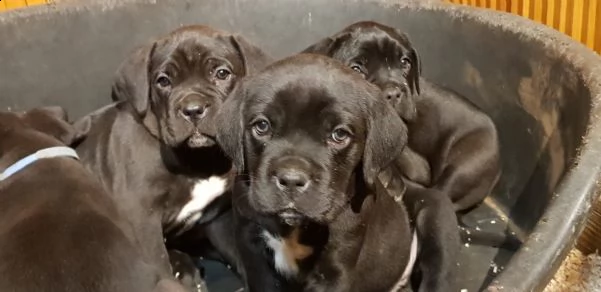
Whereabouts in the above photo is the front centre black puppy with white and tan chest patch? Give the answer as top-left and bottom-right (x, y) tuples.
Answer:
(217, 54), (459, 292)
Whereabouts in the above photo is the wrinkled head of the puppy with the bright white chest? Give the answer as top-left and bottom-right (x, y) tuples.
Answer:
(113, 26), (268, 148)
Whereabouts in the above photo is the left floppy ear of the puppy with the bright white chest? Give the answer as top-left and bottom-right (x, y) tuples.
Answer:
(111, 42), (156, 116)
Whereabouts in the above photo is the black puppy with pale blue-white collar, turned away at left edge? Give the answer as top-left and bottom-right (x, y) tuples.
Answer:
(0, 107), (185, 292)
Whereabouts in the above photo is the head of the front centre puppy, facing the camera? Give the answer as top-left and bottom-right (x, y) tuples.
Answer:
(217, 54), (407, 223)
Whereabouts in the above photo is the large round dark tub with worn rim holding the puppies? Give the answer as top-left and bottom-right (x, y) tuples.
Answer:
(0, 0), (601, 291)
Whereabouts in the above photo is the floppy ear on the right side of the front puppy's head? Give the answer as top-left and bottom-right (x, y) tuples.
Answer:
(363, 99), (407, 187)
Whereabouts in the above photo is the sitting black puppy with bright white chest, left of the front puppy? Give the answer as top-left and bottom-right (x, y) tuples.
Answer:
(77, 25), (269, 282)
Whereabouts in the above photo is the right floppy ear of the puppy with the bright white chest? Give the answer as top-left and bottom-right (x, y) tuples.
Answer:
(230, 35), (273, 76)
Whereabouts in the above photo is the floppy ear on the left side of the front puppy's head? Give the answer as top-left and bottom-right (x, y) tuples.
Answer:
(215, 82), (246, 173)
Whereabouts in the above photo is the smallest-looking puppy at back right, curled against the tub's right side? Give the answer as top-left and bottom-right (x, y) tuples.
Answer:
(303, 21), (501, 211)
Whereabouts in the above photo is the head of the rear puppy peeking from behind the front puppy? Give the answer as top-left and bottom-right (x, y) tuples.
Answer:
(304, 21), (421, 121)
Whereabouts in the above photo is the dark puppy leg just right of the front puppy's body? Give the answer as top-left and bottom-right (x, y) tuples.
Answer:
(403, 184), (460, 292)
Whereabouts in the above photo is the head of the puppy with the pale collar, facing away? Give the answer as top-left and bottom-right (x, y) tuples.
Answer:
(0, 106), (90, 167)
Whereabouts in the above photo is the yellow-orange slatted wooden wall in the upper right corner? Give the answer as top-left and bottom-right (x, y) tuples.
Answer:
(446, 0), (601, 53)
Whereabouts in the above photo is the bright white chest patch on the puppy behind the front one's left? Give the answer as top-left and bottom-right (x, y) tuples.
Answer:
(176, 176), (227, 222)
